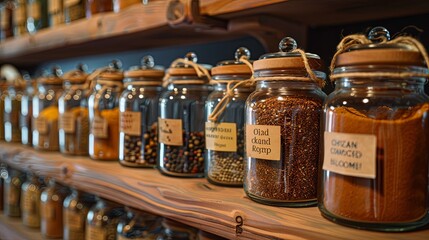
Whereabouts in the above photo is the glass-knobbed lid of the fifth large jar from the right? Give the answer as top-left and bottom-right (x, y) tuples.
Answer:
(124, 55), (164, 78)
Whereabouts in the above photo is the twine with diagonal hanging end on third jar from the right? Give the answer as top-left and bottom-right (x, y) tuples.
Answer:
(208, 56), (255, 122)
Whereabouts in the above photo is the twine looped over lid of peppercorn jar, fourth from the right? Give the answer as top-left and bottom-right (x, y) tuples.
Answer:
(162, 58), (212, 87)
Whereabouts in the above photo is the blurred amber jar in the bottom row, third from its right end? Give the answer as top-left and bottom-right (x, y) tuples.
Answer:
(85, 198), (125, 240)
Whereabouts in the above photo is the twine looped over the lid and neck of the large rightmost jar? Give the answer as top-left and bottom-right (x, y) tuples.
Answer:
(329, 27), (429, 81)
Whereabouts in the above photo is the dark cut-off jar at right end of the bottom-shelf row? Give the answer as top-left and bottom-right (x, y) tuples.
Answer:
(156, 218), (198, 240)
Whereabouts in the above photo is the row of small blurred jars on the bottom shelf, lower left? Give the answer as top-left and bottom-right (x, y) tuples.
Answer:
(0, 166), (223, 240)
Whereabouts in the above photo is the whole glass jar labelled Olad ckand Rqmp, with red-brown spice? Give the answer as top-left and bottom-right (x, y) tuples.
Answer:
(244, 37), (326, 207)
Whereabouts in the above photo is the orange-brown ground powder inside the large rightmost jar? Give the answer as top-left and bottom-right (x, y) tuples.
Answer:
(322, 104), (429, 222)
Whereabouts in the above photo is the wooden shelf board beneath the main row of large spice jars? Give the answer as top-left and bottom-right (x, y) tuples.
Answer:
(0, 143), (429, 240)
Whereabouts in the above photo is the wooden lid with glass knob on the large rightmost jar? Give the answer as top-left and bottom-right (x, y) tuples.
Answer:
(335, 27), (425, 67)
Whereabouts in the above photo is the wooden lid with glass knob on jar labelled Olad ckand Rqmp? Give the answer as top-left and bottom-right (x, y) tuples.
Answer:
(253, 37), (323, 71)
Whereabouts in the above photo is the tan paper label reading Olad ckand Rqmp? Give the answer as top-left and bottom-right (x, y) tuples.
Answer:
(246, 125), (281, 161)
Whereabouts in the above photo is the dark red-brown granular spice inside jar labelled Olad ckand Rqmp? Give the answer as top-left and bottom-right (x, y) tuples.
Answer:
(247, 96), (322, 200)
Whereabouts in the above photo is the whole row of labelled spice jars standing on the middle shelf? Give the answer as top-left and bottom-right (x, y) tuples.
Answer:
(1, 27), (429, 234)
